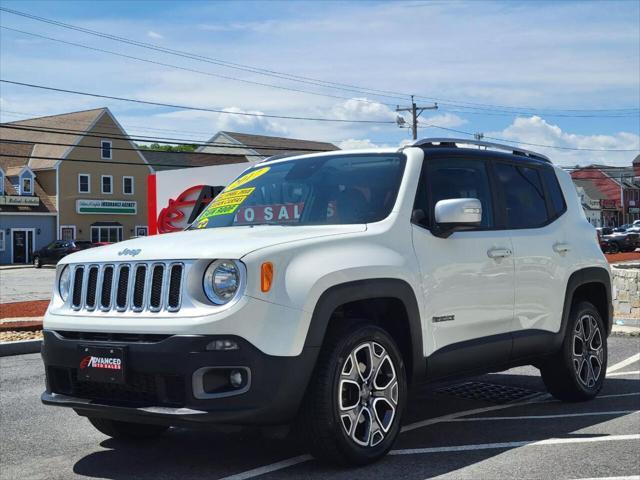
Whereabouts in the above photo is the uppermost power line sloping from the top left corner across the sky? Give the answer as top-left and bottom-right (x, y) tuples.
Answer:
(0, 7), (640, 116)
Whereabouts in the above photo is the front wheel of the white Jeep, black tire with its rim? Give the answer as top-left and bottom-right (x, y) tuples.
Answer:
(297, 322), (407, 465)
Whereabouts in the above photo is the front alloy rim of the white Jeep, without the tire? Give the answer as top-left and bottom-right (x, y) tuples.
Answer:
(338, 342), (398, 447)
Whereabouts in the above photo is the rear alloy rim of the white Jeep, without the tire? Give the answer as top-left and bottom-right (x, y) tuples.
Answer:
(572, 314), (604, 388)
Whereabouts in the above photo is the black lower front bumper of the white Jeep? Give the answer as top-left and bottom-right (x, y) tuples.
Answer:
(42, 330), (318, 426)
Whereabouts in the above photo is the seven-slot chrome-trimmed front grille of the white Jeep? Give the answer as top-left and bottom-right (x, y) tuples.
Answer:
(70, 262), (184, 312)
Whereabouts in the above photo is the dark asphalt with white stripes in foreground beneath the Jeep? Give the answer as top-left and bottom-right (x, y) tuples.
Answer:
(0, 336), (640, 480)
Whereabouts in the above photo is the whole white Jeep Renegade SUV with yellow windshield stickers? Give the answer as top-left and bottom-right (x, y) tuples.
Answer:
(42, 139), (612, 464)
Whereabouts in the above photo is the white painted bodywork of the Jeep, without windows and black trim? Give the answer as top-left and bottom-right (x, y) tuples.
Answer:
(44, 147), (608, 356)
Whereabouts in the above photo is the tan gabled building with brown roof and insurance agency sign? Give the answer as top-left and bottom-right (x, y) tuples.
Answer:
(0, 108), (152, 261)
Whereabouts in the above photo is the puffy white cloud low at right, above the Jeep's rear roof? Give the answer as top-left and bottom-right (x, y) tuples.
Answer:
(485, 115), (640, 166)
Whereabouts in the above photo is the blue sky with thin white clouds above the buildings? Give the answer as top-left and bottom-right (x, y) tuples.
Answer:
(0, 0), (640, 165)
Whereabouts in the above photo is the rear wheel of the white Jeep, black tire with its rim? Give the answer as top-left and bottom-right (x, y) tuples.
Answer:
(540, 301), (607, 402)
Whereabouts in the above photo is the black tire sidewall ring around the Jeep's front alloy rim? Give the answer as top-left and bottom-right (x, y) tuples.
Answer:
(328, 326), (407, 464)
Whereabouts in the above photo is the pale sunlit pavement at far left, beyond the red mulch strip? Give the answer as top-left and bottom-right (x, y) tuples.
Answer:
(0, 266), (56, 303)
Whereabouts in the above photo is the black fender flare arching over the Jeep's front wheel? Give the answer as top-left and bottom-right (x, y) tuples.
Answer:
(305, 278), (426, 381)
